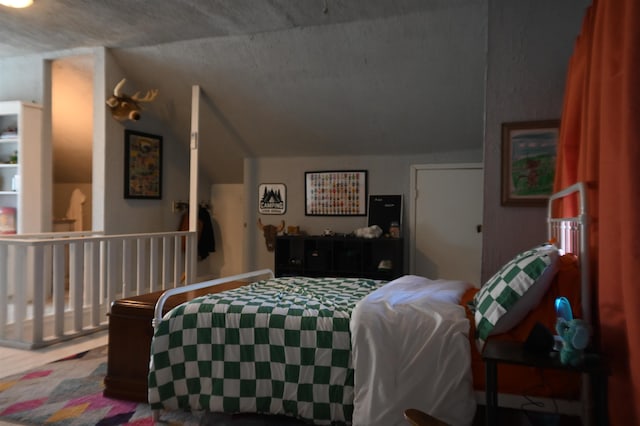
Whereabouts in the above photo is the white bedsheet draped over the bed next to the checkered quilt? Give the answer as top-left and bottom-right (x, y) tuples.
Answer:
(351, 275), (476, 426)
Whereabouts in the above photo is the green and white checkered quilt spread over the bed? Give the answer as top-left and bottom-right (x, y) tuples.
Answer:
(149, 277), (385, 424)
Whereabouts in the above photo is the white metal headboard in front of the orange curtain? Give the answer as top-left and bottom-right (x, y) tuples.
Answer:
(547, 182), (591, 324)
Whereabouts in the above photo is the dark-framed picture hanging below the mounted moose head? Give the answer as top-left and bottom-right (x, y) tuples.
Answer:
(124, 130), (162, 200)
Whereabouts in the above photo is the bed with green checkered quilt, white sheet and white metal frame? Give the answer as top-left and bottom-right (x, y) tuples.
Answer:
(149, 181), (588, 426)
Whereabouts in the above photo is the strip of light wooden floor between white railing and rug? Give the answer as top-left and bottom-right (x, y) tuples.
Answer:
(0, 330), (108, 378)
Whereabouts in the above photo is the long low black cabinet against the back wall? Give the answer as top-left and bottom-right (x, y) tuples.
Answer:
(275, 235), (404, 280)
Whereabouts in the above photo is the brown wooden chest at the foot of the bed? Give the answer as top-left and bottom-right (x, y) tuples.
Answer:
(103, 281), (247, 402)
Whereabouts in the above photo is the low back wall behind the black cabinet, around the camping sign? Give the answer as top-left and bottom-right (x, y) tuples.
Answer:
(243, 150), (482, 270)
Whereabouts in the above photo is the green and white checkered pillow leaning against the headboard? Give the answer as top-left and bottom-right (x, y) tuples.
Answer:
(474, 244), (559, 350)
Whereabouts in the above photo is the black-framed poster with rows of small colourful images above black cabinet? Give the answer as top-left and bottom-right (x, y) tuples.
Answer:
(304, 170), (367, 216)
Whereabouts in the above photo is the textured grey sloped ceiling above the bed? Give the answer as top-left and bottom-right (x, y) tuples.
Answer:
(0, 0), (487, 183)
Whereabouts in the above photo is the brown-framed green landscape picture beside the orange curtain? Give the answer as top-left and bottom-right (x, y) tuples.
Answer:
(502, 120), (560, 206)
